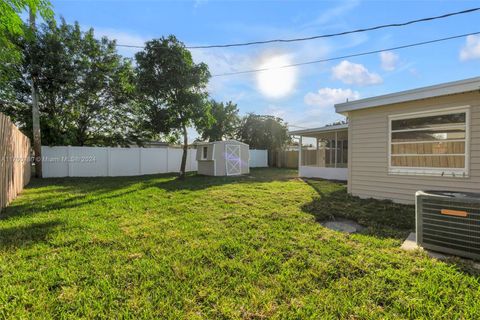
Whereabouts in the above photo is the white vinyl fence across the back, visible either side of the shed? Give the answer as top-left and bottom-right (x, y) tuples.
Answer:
(42, 146), (267, 178)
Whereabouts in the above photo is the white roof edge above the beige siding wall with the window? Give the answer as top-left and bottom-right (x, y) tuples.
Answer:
(335, 77), (480, 113)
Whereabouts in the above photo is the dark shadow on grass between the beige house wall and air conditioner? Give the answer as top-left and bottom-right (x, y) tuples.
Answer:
(302, 179), (415, 240)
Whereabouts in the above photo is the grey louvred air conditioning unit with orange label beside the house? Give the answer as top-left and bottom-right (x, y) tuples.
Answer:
(415, 191), (480, 259)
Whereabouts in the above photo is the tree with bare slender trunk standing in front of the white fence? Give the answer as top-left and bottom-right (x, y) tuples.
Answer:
(135, 35), (212, 178)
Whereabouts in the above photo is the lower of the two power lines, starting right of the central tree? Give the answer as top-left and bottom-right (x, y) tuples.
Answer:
(212, 31), (480, 77)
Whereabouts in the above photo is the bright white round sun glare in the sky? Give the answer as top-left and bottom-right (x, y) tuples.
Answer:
(257, 55), (297, 98)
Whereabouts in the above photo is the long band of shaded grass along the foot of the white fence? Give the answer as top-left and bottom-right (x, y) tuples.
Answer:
(0, 168), (297, 220)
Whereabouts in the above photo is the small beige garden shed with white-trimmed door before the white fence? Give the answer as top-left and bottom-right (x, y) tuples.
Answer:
(197, 140), (250, 176)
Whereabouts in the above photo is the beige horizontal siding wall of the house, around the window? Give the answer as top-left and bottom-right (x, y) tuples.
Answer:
(348, 91), (480, 204)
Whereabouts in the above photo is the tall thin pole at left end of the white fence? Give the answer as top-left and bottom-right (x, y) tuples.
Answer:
(30, 8), (42, 178)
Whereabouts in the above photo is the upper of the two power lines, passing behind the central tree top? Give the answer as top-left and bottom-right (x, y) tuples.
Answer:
(117, 7), (480, 49)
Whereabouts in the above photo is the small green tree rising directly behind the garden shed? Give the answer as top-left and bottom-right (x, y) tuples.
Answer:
(198, 100), (240, 141)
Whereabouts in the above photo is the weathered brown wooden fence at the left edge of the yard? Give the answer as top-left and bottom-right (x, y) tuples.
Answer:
(0, 113), (31, 210)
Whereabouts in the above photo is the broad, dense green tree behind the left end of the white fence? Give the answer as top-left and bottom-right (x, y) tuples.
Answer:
(0, 20), (143, 146)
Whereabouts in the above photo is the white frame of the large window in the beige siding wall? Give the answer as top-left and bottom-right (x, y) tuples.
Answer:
(387, 106), (471, 178)
